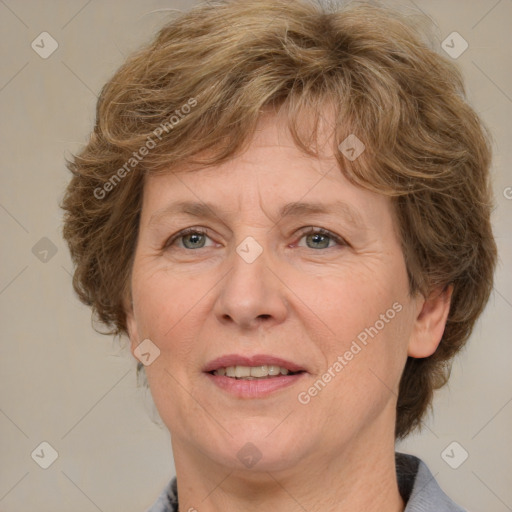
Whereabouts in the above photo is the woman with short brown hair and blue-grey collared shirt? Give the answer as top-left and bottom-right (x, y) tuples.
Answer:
(63, 0), (496, 512)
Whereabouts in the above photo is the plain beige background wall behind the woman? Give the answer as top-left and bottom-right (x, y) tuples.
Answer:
(0, 0), (512, 512)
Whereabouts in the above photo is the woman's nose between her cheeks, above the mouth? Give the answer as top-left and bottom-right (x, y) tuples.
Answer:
(214, 238), (288, 330)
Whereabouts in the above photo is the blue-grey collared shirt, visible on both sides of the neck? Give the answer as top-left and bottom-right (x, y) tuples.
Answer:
(146, 453), (467, 512)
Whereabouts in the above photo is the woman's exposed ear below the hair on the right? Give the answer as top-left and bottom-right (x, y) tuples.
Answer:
(407, 284), (453, 358)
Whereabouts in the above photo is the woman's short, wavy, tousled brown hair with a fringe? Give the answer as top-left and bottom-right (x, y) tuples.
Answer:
(62, 0), (497, 438)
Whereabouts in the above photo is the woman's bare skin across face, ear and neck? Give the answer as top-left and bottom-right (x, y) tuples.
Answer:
(127, 111), (451, 512)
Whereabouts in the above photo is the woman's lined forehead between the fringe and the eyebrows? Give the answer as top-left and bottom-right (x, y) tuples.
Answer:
(138, 116), (391, 235)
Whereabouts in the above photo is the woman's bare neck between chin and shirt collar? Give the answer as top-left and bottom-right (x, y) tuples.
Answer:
(173, 410), (404, 512)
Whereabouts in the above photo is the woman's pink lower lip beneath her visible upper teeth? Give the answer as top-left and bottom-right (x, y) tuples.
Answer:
(206, 372), (306, 398)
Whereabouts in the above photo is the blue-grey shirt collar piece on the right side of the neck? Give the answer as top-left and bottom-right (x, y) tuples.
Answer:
(395, 453), (467, 512)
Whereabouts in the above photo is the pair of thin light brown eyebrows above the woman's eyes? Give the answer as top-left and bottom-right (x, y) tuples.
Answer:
(148, 201), (365, 229)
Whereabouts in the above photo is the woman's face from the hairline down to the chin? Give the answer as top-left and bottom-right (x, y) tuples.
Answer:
(128, 110), (438, 470)
